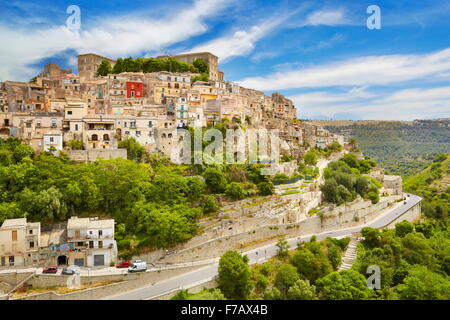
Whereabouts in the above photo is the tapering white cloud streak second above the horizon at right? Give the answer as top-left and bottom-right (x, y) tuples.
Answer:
(240, 48), (450, 90)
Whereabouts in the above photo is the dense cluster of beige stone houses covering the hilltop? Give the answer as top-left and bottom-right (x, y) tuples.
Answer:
(0, 52), (344, 161)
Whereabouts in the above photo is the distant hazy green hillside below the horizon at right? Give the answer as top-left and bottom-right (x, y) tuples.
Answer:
(324, 120), (450, 178)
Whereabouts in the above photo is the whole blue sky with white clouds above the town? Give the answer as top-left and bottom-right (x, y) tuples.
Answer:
(0, 0), (450, 120)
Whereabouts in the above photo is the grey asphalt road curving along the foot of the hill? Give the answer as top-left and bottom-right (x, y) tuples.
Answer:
(106, 194), (422, 300)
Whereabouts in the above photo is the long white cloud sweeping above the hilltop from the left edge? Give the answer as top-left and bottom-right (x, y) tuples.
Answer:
(0, 0), (232, 80)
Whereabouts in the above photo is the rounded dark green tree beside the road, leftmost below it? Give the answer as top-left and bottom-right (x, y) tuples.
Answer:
(218, 251), (252, 300)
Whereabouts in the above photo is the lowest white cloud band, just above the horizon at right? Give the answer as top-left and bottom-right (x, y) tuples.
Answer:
(290, 86), (450, 120)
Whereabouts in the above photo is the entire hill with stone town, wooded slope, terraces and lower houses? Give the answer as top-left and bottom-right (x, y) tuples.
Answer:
(0, 53), (422, 299)
